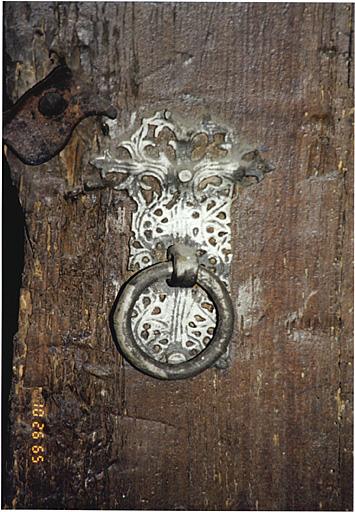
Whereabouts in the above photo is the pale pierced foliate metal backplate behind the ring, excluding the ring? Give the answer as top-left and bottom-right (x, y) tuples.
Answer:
(93, 111), (272, 368)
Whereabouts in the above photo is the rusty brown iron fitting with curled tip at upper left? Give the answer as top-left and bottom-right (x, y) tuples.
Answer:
(3, 64), (117, 165)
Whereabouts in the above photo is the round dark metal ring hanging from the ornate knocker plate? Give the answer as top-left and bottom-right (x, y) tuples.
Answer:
(114, 262), (233, 380)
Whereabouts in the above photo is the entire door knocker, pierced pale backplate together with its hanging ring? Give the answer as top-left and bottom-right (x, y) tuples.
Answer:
(92, 111), (273, 379)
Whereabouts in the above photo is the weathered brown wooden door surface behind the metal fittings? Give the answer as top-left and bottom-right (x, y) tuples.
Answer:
(5, 2), (353, 510)
